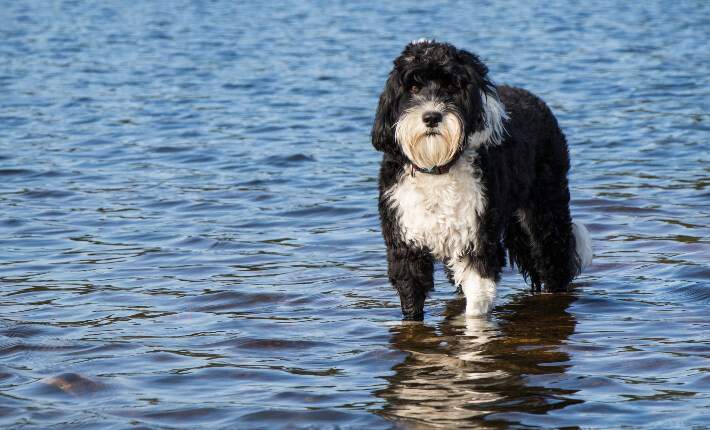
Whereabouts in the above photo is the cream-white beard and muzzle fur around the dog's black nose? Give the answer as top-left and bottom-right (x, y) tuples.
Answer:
(395, 102), (463, 169)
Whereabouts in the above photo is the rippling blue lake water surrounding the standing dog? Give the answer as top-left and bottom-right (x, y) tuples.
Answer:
(0, 0), (710, 429)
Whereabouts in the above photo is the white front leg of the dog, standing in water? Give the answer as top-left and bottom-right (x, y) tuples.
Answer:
(448, 256), (497, 316)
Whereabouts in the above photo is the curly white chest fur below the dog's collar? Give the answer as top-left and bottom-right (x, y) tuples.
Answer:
(388, 159), (485, 259)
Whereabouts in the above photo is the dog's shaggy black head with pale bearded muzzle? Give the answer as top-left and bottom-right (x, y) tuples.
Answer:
(372, 40), (506, 169)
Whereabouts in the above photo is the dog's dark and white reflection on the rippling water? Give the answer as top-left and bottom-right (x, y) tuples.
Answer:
(378, 293), (579, 428)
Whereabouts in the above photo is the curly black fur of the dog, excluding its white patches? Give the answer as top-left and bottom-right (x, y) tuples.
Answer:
(372, 41), (580, 320)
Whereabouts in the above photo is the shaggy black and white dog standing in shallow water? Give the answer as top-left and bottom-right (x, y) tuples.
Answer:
(372, 40), (592, 320)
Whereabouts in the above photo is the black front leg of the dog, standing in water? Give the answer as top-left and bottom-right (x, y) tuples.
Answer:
(387, 249), (434, 321)
